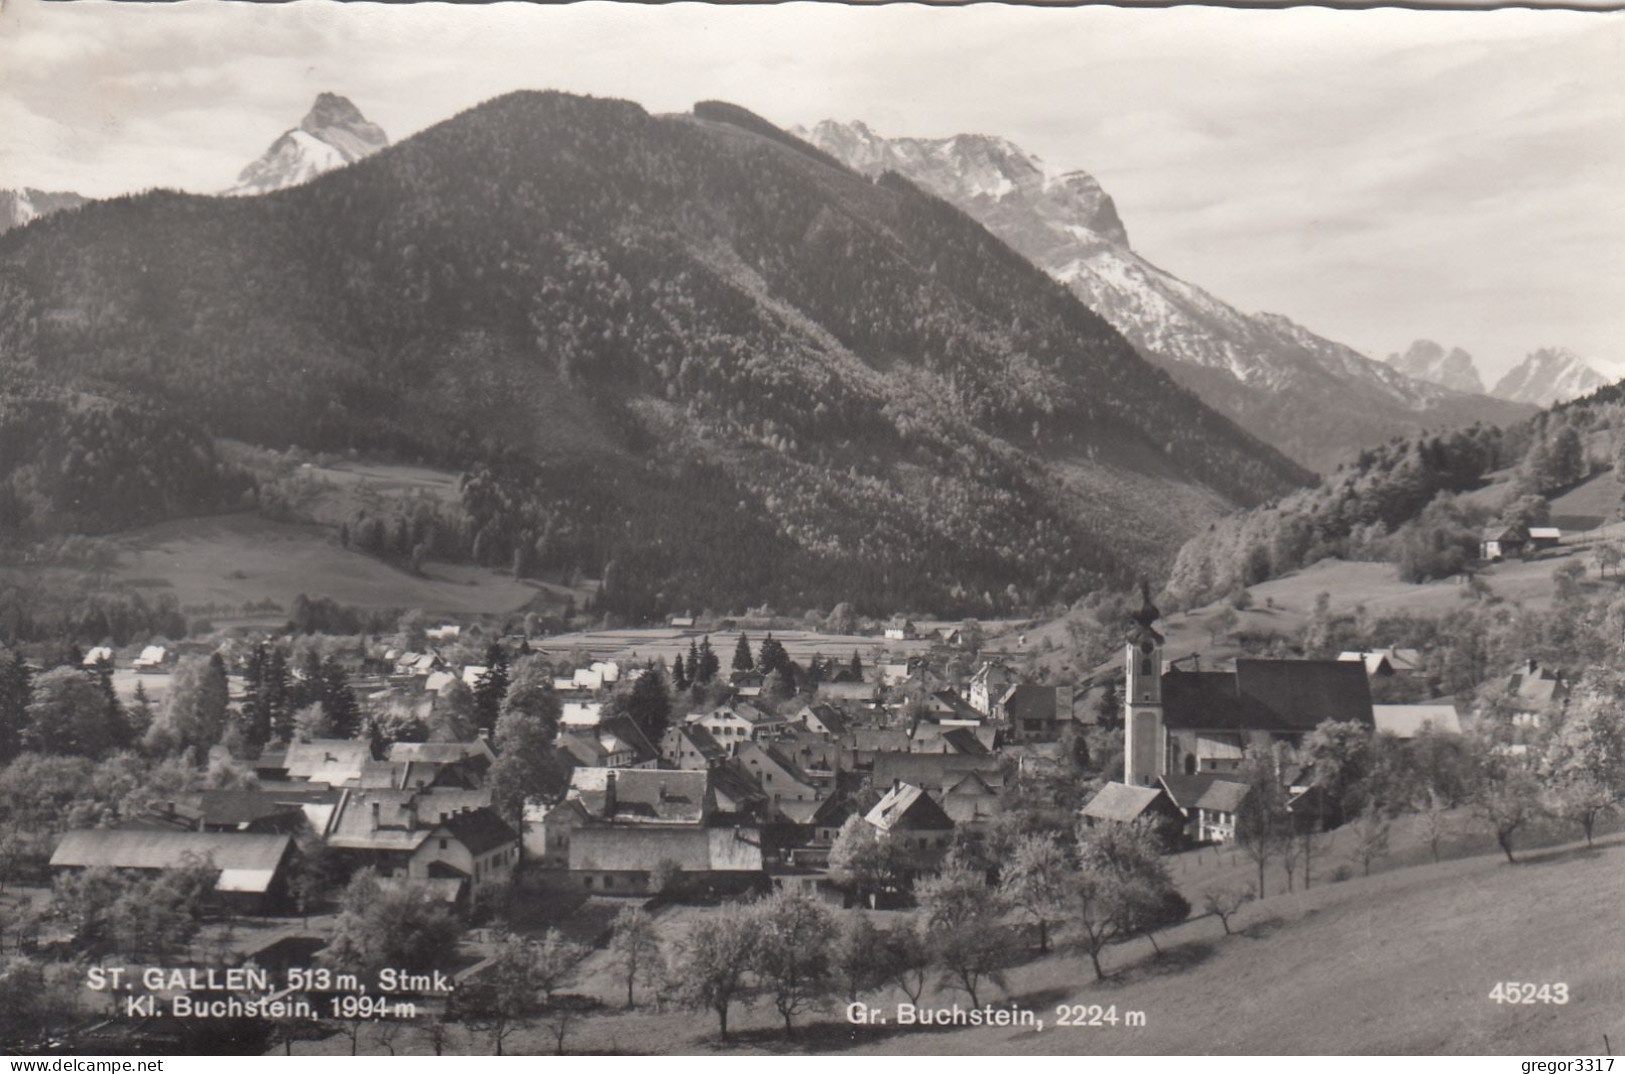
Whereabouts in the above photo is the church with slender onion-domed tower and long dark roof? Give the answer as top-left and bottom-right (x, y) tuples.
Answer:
(1123, 590), (1375, 786)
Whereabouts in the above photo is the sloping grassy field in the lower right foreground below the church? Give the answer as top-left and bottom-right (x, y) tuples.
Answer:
(296, 822), (1625, 1055)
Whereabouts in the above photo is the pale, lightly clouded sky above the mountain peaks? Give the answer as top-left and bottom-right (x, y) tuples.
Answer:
(0, 0), (1625, 383)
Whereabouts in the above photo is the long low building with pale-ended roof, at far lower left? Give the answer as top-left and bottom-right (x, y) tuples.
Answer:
(50, 829), (297, 913)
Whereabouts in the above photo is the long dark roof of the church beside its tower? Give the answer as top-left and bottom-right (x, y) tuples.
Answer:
(1162, 660), (1372, 731)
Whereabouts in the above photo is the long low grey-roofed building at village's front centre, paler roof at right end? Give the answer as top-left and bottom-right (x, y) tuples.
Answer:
(567, 825), (767, 895)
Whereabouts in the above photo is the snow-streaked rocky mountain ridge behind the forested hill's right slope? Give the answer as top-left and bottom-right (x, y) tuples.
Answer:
(800, 120), (1531, 471)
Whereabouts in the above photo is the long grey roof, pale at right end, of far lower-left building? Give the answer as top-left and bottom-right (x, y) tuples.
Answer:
(50, 829), (293, 892)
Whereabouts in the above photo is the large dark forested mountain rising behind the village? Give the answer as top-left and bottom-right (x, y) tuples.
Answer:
(0, 93), (1307, 616)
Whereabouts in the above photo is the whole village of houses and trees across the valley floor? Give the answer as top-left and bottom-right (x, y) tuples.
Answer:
(0, 513), (1622, 1055)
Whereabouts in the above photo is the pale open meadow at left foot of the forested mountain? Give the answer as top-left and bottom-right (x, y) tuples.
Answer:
(82, 513), (564, 626)
